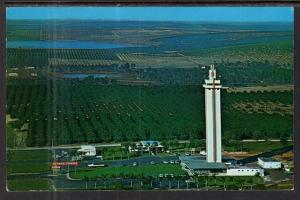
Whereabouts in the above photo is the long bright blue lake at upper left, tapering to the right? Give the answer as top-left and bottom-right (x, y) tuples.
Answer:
(7, 40), (137, 49)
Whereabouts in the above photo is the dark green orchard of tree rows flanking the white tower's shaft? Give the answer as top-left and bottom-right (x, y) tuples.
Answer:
(7, 80), (293, 146)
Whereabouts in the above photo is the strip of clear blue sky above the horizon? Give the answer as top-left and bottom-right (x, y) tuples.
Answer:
(6, 6), (294, 22)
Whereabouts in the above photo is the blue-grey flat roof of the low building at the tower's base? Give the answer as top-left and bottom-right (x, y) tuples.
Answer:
(179, 156), (227, 170)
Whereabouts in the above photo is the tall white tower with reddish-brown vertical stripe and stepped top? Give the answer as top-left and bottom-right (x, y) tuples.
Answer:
(203, 65), (222, 162)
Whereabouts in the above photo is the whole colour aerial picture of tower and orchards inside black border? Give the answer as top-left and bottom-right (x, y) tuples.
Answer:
(6, 6), (294, 192)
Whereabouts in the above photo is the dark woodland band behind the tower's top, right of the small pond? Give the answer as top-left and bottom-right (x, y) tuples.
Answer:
(140, 61), (293, 85)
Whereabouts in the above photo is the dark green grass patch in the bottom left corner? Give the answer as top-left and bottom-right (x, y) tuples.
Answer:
(7, 176), (49, 191)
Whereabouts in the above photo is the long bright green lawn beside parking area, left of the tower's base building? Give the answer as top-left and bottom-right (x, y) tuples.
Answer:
(70, 164), (185, 179)
